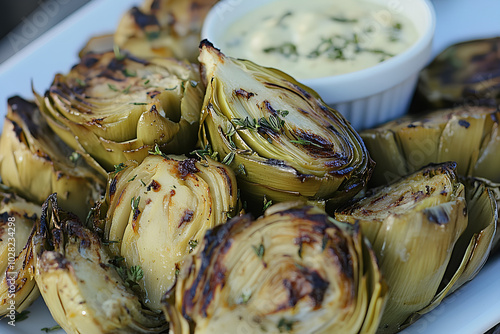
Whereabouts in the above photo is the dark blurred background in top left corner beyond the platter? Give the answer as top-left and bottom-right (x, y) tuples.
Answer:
(0, 0), (95, 63)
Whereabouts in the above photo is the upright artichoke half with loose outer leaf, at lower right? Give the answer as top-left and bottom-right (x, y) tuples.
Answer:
(335, 162), (497, 333)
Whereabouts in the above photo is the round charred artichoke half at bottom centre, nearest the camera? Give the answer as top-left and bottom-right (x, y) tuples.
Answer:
(164, 202), (387, 334)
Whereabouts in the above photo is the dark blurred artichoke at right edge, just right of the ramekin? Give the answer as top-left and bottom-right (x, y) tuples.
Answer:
(416, 37), (500, 109)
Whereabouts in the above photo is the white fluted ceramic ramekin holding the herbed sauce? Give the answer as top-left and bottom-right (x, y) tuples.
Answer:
(202, 0), (436, 130)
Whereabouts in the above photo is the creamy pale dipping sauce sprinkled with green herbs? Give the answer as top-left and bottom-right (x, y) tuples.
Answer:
(220, 0), (418, 79)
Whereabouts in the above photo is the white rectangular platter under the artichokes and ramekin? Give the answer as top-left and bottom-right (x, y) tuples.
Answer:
(0, 0), (500, 334)
